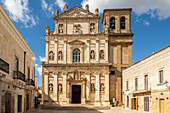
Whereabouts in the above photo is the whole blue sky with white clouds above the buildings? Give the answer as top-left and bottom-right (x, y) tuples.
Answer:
(0, 0), (170, 86)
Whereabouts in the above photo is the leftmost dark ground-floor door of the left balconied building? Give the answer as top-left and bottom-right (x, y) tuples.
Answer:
(5, 93), (11, 113)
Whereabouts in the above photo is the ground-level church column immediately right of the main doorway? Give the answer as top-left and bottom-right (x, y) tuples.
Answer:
(86, 72), (91, 101)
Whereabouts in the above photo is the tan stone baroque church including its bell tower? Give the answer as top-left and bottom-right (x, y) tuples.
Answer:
(42, 5), (133, 106)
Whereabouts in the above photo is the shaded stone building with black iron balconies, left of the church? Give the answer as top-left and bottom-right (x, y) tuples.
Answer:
(0, 5), (36, 113)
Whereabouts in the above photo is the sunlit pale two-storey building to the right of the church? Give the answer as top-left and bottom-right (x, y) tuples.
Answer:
(123, 46), (170, 113)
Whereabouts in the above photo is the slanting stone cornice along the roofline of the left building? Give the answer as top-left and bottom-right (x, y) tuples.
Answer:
(0, 4), (35, 57)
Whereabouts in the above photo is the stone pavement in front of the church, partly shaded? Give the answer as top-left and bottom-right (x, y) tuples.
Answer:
(26, 107), (148, 113)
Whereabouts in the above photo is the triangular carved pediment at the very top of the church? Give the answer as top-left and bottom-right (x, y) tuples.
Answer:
(55, 6), (100, 18)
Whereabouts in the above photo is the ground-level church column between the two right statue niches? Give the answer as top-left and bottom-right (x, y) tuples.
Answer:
(95, 72), (100, 106)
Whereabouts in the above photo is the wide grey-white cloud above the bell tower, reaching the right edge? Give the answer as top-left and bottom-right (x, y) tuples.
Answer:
(82, 0), (170, 19)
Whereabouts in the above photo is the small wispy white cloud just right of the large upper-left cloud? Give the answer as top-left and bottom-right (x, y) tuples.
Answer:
(41, 0), (54, 17)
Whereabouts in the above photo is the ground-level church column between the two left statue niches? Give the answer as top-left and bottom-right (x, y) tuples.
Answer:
(53, 72), (58, 101)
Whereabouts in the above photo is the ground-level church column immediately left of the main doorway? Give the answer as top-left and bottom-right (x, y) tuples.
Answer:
(62, 72), (67, 102)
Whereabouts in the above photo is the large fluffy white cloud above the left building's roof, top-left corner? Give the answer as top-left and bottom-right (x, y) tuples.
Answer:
(2, 0), (37, 28)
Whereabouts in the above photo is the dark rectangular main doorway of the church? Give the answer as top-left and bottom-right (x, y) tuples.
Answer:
(72, 85), (81, 104)
